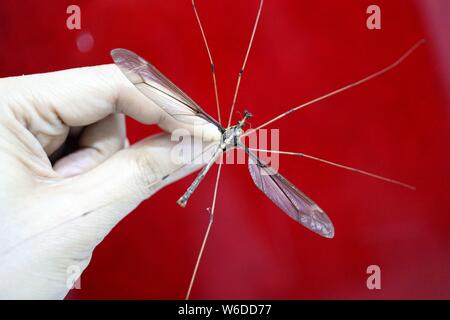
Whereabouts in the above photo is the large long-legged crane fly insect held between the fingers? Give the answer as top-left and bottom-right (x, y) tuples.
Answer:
(111, 0), (424, 299)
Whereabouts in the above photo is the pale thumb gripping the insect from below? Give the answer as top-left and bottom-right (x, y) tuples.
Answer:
(52, 133), (217, 231)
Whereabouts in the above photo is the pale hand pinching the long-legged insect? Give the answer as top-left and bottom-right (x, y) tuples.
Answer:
(0, 65), (220, 299)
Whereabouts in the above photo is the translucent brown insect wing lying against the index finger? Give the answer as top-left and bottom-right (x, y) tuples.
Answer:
(111, 49), (223, 131)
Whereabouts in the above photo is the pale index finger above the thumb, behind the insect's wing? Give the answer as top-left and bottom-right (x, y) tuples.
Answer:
(0, 64), (219, 140)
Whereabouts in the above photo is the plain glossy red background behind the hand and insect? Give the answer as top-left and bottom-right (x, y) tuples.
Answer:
(0, 0), (450, 299)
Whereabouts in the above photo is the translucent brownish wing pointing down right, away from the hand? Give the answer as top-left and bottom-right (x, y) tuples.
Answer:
(247, 150), (334, 238)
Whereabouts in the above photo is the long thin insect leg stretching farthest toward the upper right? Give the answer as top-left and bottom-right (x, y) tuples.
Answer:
(242, 39), (425, 136)
